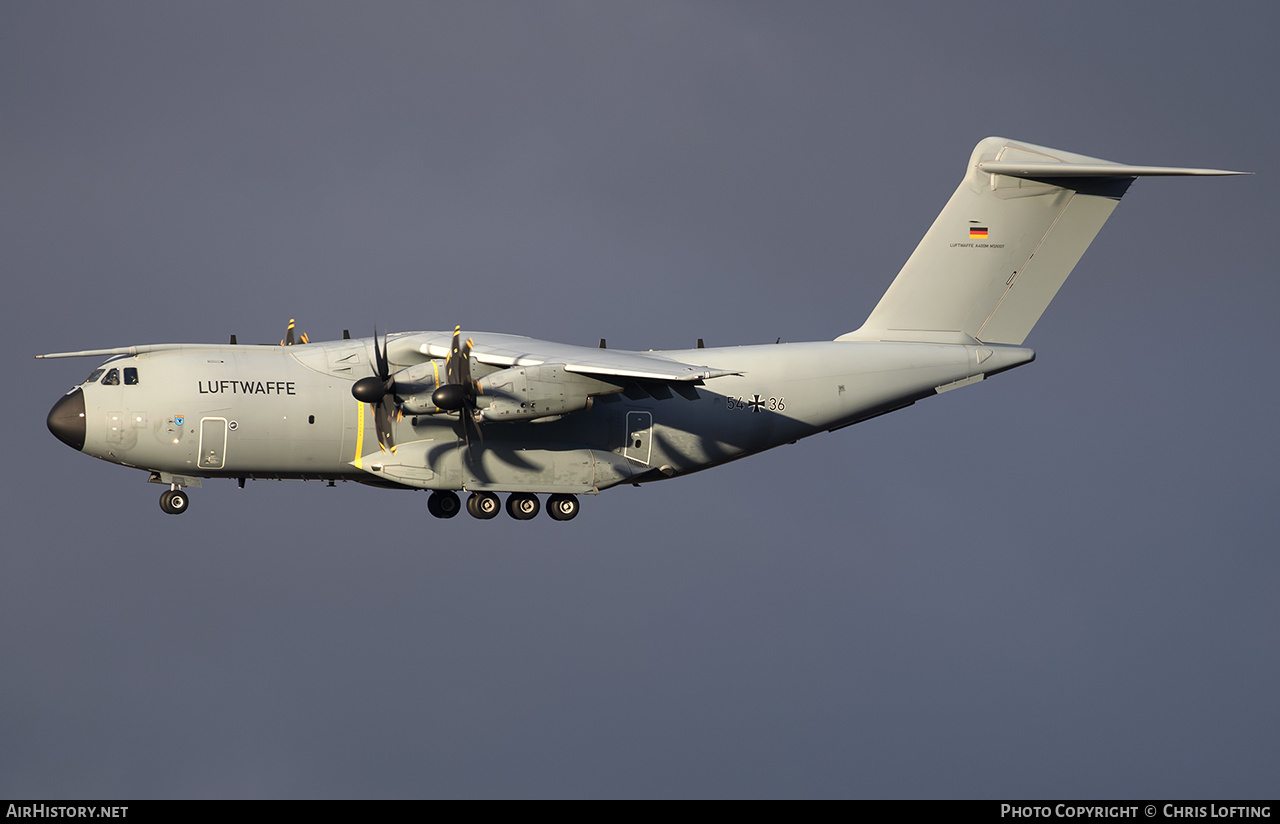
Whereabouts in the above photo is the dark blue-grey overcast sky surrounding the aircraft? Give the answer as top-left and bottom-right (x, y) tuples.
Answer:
(0, 0), (1280, 798)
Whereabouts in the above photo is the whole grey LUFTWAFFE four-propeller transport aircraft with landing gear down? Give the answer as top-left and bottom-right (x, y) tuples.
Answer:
(36, 137), (1244, 521)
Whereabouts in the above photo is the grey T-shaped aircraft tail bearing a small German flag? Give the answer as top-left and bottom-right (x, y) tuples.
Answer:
(837, 137), (1243, 345)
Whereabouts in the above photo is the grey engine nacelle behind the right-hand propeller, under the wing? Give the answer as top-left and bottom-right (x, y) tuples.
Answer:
(476, 363), (622, 421)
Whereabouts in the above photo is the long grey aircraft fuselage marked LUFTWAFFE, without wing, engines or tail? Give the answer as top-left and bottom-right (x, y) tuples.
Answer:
(50, 333), (1034, 493)
